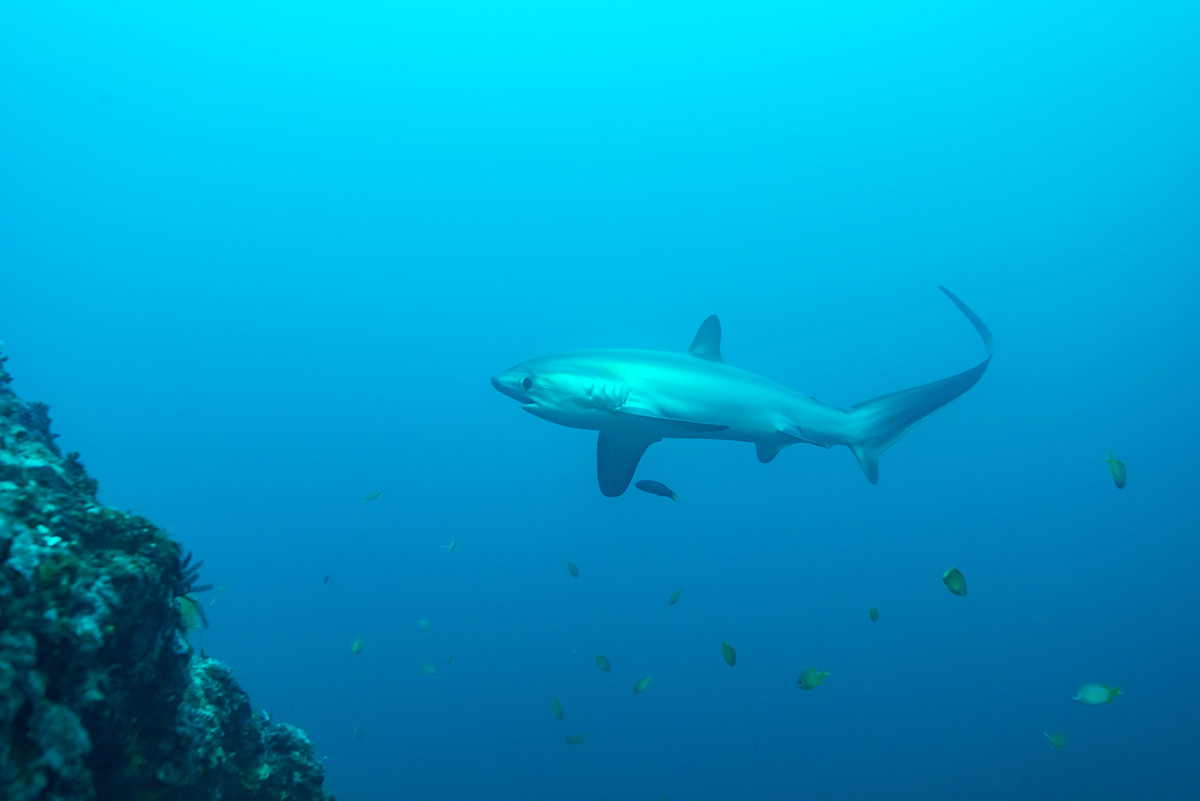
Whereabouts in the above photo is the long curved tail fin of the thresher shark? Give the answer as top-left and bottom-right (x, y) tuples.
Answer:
(847, 287), (992, 484)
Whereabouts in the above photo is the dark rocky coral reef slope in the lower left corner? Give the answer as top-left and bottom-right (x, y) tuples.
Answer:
(0, 347), (332, 801)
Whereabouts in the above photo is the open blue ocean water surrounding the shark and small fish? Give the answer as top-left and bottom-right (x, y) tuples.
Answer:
(0, 1), (1200, 801)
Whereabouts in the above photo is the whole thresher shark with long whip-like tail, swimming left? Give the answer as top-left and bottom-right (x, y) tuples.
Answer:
(492, 287), (994, 498)
